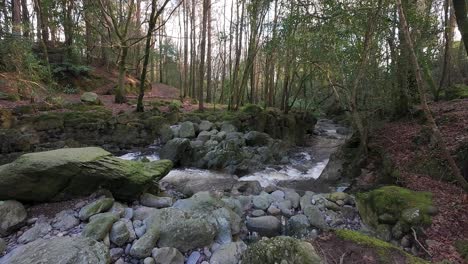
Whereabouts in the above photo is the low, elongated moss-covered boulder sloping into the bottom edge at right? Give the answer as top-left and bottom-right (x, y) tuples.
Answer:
(334, 229), (429, 264)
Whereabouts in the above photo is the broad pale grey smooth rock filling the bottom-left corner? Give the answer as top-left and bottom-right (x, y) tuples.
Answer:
(0, 237), (110, 264)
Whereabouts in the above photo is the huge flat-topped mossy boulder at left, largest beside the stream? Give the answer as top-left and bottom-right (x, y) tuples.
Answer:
(0, 147), (172, 202)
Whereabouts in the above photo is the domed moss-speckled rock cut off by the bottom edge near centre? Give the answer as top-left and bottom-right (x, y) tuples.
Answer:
(242, 237), (324, 264)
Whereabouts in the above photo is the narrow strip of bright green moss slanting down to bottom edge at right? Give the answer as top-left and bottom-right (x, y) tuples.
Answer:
(335, 229), (428, 264)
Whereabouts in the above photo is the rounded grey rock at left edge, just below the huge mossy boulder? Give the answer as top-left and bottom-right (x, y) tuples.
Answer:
(0, 200), (27, 236)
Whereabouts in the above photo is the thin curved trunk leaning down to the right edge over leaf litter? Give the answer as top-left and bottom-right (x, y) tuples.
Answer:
(396, 0), (468, 192)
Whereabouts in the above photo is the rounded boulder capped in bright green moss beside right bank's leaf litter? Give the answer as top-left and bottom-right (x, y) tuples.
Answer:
(356, 186), (436, 228)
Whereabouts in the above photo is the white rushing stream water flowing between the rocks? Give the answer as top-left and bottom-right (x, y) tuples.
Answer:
(120, 119), (348, 192)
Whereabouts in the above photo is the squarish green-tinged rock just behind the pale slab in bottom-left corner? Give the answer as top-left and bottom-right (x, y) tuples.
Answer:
(81, 213), (118, 241)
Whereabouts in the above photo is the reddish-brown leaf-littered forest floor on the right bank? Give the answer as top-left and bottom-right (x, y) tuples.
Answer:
(372, 100), (468, 263)
